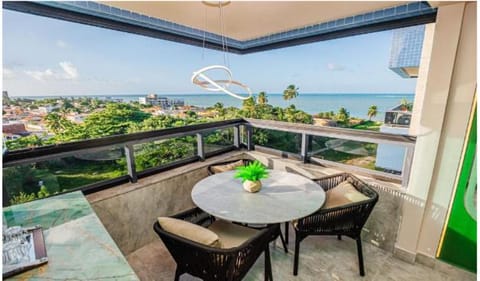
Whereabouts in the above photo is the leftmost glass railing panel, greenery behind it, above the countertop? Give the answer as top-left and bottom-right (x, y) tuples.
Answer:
(3, 147), (127, 205)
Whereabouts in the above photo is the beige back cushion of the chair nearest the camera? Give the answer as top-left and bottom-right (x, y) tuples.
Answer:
(158, 217), (220, 247)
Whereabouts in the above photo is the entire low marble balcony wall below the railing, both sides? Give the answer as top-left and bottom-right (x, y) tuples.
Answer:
(87, 151), (415, 255)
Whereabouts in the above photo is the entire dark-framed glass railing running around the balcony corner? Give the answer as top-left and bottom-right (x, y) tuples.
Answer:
(3, 119), (415, 206)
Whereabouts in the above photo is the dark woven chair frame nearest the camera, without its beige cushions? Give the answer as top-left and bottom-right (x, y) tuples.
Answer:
(153, 208), (280, 281)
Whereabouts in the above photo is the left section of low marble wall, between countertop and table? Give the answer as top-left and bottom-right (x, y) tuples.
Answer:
(87, 152), (248, 256)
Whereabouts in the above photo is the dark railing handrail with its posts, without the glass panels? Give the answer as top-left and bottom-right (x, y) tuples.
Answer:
(3, 118), (416, 185)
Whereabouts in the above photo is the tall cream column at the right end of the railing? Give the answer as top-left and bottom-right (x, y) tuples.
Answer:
(395, 3), (465, 261)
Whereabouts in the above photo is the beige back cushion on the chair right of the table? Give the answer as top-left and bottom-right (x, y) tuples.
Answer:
(322, 181), (369, 209)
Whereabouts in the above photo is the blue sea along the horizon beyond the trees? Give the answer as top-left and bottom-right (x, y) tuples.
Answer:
(12, 93), (414, 121)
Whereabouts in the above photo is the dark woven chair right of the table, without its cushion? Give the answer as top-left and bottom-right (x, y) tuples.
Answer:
(293, 173), (378, 276)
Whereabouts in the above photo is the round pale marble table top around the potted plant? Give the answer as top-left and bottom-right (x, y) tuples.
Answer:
(192, 170), (325, 224)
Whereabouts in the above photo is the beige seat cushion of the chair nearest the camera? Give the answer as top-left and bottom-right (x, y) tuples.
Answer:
(208, 220), (258, 249)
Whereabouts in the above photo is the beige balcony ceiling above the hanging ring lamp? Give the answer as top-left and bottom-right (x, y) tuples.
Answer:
(101, 1), (409, 41)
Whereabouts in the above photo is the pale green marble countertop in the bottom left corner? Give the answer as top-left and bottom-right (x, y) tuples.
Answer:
(3, 191), (139, 280)
